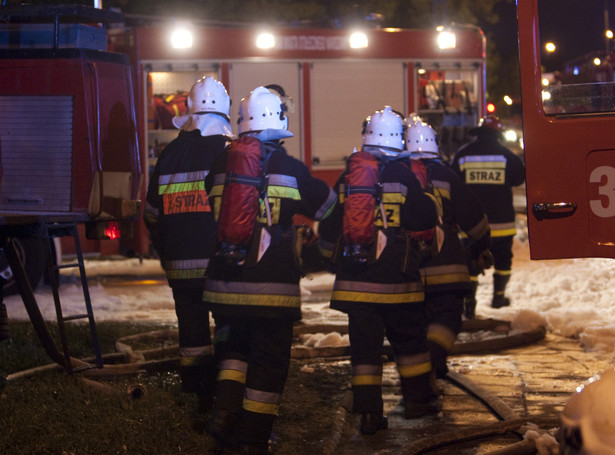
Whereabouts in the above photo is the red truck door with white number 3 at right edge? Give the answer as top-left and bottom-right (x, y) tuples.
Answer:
(517, 0), (615, 259)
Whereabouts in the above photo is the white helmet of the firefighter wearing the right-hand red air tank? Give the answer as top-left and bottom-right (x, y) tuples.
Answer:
(363, 106), (404, 155)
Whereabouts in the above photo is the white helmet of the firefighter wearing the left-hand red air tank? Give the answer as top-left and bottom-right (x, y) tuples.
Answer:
(237, 86), (293, 140)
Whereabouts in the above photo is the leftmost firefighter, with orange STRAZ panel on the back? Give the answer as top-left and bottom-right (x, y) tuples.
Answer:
(144, 76), (232, 410)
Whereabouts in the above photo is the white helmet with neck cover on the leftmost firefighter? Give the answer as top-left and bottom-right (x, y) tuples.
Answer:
(173, 76), (232, 137)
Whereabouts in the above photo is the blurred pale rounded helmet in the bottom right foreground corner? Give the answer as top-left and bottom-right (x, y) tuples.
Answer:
(558, 369), (615, 455)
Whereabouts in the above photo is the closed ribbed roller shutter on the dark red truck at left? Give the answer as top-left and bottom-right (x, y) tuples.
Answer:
(0, 96), (73, 212)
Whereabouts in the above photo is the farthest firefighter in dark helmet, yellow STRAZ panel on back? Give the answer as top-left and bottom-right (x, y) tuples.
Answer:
(452, 114), (525, 317)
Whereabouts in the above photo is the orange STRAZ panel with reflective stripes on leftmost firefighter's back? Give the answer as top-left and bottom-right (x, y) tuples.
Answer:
(158, 172), (211, 215)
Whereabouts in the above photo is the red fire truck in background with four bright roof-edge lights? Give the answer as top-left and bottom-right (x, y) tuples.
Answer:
(110, 21), (485, 254)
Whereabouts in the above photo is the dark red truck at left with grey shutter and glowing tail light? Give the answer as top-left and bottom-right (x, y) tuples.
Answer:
(0, 5), (142, 287)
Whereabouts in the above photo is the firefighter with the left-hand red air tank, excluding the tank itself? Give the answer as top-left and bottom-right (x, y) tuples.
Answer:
(203, 86), (336, 454)
